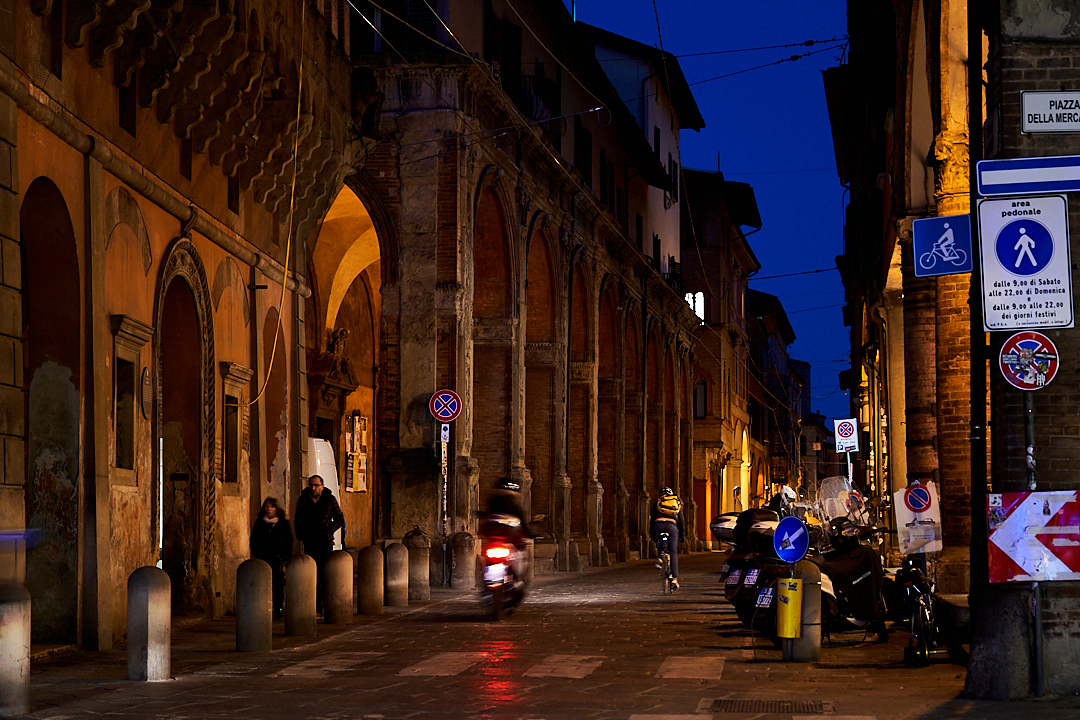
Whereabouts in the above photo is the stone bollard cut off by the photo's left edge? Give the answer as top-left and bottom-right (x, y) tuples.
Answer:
(0, 582), (30, 718)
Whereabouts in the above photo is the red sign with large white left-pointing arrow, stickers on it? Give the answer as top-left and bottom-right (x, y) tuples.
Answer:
(986, 490), (1080, 583)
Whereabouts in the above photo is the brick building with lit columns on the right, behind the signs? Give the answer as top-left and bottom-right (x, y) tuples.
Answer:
(825, 0), (1080, 698)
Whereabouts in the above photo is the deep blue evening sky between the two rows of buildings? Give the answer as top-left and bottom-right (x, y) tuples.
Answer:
(564, 0), (849, 426)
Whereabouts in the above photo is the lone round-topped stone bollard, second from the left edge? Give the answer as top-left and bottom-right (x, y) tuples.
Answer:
(127, 566), (173, 682)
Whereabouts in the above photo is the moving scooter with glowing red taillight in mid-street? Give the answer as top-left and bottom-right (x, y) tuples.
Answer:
(480, 514), (529, 620)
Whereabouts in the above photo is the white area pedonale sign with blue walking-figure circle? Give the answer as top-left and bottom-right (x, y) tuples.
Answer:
(978, 195), (1074, 330)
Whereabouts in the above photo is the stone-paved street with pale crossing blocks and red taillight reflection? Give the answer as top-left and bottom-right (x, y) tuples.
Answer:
(8, 554), (1080, 720)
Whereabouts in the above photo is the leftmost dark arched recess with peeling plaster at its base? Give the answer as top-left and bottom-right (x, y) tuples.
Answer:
(19, 178), (82, 643)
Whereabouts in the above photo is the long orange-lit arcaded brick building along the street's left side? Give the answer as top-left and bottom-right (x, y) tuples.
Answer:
(0, 0), (702, 648)
